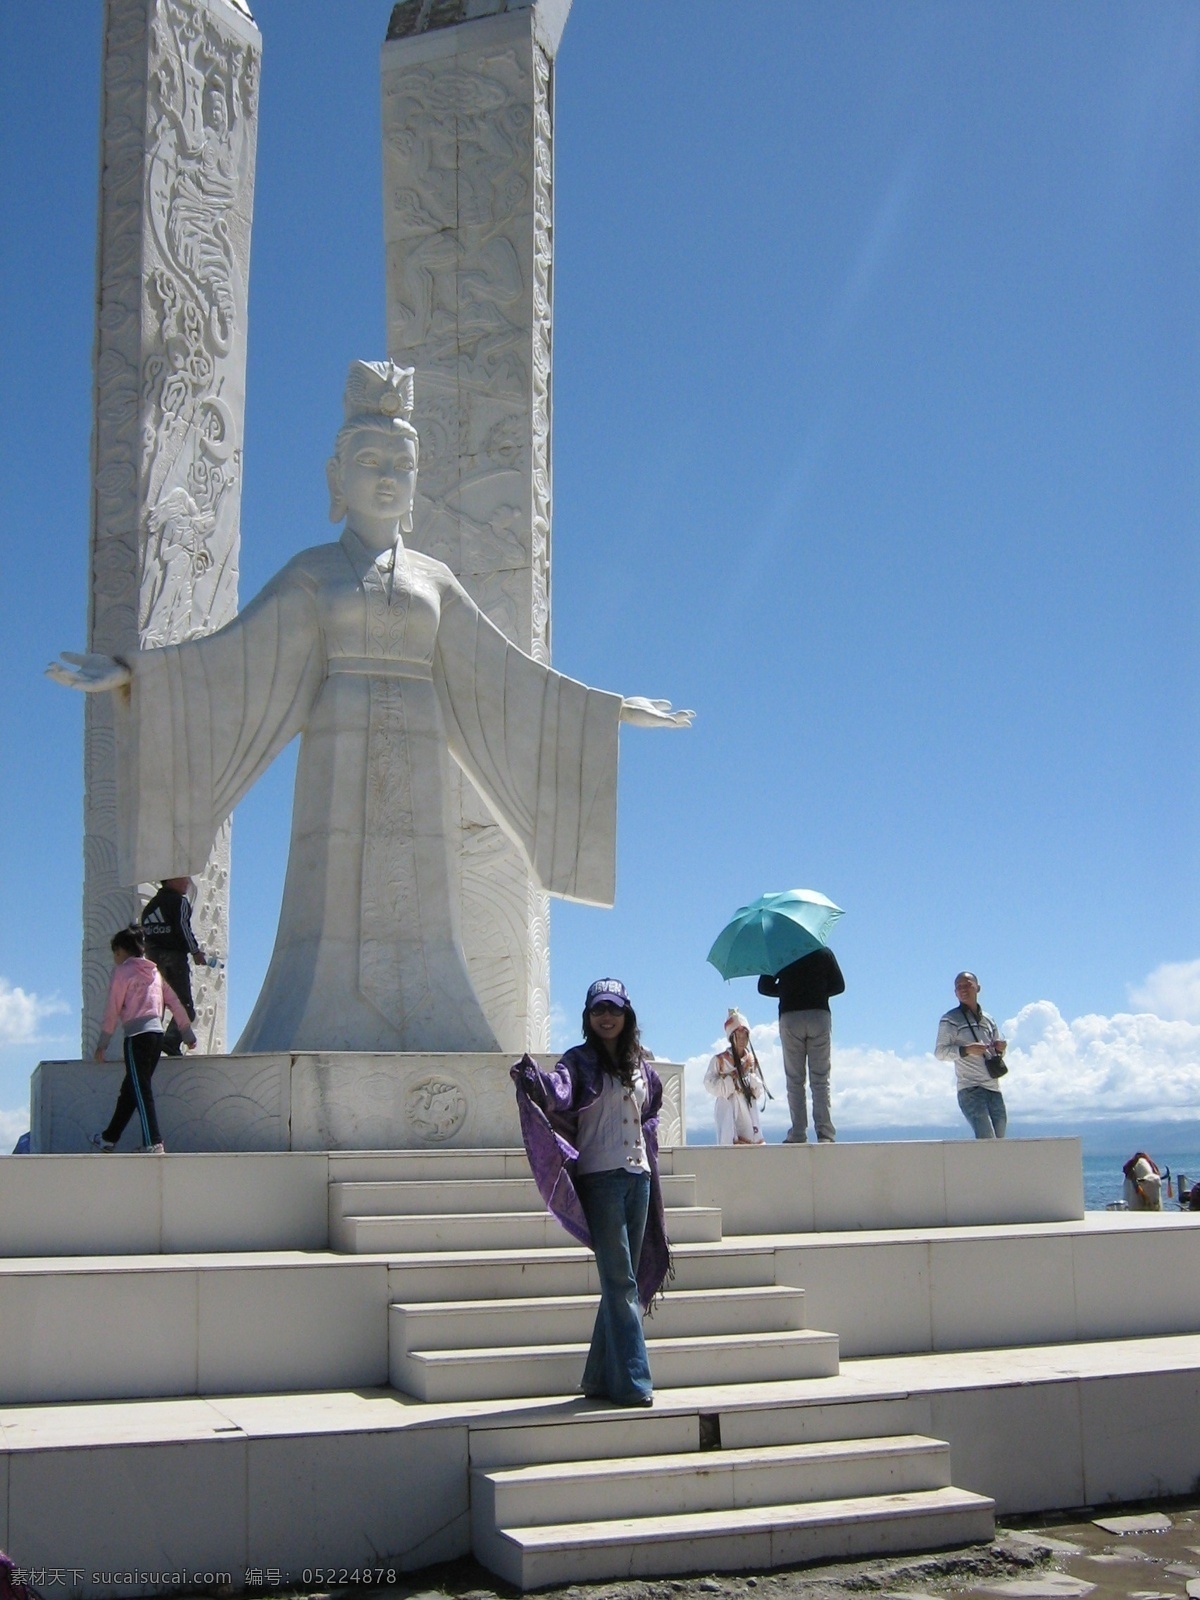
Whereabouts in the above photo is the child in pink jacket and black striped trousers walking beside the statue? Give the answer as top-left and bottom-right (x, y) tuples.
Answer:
(91, 928), (195, 1155)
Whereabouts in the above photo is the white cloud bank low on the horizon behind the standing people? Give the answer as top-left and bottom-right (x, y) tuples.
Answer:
(686, 962), (1200, 1138)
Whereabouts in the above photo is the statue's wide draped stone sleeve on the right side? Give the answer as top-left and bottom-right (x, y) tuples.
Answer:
(434, 579), (621, 906)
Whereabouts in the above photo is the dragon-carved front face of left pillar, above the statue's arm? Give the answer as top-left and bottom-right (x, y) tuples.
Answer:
(138, 0), (258, 646)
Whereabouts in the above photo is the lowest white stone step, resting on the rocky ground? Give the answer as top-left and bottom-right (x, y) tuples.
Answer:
(475, 1488), (995, 1589)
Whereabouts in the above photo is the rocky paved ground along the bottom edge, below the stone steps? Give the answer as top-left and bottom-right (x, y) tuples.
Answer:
(296, 1501), (1200, 1600)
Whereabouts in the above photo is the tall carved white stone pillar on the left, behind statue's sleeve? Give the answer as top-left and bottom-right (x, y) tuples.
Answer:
(83, 0), (261, 1054)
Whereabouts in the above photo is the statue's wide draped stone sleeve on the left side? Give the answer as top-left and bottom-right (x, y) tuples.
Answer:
(115, 568), (325, 885)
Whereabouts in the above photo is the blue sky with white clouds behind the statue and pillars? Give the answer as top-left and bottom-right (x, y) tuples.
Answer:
(0, 0), (1200, 1145)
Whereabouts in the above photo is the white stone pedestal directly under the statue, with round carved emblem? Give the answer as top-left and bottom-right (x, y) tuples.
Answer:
(30, 1051), (685, 1155)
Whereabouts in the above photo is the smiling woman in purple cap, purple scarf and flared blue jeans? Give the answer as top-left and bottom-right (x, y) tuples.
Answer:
(512, 978), (670, 1405)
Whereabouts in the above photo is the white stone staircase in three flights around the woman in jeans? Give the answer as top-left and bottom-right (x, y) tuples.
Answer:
(330, 1152), (994, 1589)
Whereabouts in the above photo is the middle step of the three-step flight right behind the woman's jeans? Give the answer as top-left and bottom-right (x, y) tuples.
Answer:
(389, 1285), (805, 1350)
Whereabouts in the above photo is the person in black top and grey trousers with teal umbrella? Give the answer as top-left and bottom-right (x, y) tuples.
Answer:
(709, 890), (846, 1144)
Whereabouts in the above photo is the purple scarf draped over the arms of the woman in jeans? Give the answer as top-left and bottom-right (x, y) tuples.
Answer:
(509, 1045), (670, 1312)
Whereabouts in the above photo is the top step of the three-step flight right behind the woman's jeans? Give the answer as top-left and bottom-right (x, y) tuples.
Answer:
(377, 1240), (790, 1306)
